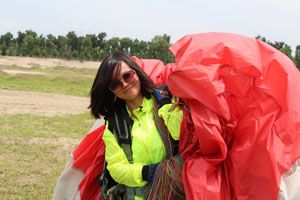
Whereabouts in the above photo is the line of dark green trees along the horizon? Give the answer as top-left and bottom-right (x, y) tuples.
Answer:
(0, 30), (300, 68)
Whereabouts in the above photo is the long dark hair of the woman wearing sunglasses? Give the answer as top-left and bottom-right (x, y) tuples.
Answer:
(89, 52), (154, 118)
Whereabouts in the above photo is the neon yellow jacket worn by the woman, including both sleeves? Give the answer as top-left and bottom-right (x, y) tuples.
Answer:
(103, 98), (183, 194)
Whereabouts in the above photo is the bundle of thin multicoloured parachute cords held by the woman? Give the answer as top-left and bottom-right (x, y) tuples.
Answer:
(144, 156), (185, 200)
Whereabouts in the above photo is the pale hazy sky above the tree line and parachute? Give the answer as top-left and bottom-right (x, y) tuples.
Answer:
(0, 0), (300, 51)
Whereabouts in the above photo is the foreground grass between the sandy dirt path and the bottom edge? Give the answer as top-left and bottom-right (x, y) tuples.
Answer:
(0, 113), (94, 200)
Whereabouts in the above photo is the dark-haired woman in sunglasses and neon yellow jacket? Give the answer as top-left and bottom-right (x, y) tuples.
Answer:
(90, 52), (182, 199)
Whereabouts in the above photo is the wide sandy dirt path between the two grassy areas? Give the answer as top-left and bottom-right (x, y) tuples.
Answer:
(0, 90), (89, 116)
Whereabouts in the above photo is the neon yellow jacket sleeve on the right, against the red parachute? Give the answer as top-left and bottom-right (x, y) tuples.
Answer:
(158, 104), (183, 140)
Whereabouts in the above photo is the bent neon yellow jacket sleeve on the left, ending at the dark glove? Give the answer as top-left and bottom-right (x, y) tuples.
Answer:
(103, 125), (147, 187)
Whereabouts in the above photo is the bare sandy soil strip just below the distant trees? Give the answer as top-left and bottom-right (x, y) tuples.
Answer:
(0, 56), (100, 68)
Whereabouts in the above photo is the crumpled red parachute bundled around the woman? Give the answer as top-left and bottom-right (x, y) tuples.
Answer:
(52, 33), (300, 200)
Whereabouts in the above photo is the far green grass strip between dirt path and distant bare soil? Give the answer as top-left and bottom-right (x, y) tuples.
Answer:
(0, 66), (96, 96)
